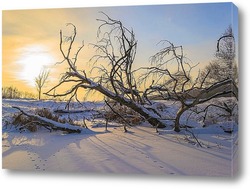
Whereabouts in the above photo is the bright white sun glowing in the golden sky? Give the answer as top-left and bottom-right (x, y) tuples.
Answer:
(17, 45), (55, 86)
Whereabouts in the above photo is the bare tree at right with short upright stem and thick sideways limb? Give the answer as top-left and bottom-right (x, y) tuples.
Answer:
(141, 41), (238, 132)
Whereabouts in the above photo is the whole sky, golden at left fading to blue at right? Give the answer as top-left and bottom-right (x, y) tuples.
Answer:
(2, 3), (238, 99)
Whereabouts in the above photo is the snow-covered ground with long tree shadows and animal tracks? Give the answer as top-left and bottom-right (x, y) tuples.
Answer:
(2, 99), (238, 176)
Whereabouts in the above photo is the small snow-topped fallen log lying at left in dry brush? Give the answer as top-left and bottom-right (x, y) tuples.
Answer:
(12, 106), (82, 133)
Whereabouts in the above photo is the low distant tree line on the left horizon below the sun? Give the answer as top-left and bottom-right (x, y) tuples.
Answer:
(2, 86), (35, 99)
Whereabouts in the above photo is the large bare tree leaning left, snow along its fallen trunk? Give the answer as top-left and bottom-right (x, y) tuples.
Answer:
(45, 13), (166, 131)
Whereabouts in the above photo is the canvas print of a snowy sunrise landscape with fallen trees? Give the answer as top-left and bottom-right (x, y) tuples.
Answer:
(2, 3), (239, 177)
